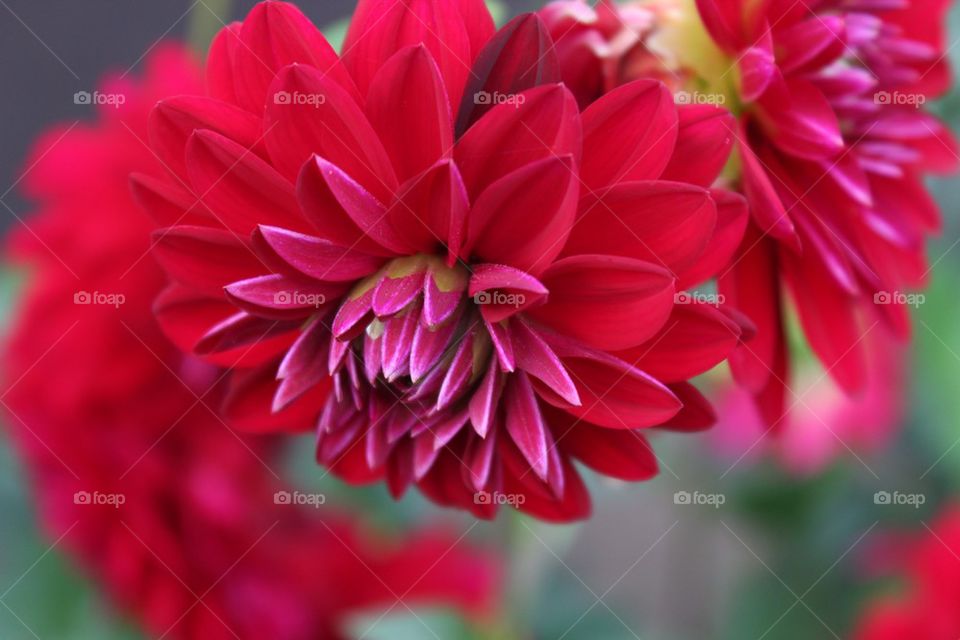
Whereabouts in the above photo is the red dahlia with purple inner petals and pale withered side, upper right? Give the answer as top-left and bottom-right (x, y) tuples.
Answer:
(541, 0), (957, 425)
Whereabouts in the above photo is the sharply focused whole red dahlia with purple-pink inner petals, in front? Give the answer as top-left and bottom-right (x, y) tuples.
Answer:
(137, 0), (745, 520)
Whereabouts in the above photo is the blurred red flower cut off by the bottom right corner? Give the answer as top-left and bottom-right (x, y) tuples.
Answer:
(851, 505), (960, 640)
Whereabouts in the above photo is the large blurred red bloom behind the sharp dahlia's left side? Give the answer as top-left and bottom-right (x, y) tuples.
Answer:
(3, 45), (496, 640)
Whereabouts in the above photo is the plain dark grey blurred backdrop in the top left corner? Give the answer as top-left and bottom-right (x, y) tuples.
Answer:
(0, 0), (344, 215)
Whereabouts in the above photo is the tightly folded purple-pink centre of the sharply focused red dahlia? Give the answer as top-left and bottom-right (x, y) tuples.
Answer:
(321, 254), (502, 444)
